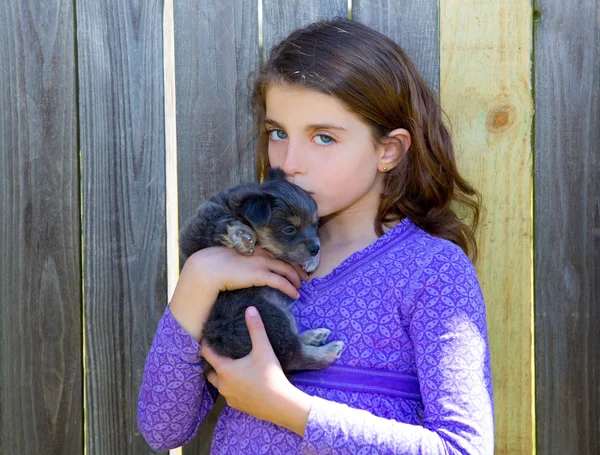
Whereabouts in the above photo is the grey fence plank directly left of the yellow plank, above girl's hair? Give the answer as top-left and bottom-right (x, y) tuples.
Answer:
(352, 0), (440, 99)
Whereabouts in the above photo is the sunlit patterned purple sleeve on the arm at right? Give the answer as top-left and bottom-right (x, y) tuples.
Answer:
(300, 246), (494, 455)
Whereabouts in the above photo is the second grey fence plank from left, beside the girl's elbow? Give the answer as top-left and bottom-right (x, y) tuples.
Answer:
(77, 0), (166, 455)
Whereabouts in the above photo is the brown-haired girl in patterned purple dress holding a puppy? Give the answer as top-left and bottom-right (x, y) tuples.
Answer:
(138, 19), (494, 455)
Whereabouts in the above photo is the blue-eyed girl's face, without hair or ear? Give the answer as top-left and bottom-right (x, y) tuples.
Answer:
(265, 85), (382, 221)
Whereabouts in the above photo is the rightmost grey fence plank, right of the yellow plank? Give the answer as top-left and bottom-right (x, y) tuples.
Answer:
(535, 0), (600, 455)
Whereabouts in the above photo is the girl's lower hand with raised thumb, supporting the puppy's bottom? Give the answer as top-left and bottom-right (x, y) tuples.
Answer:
(201, 307), (311, 436)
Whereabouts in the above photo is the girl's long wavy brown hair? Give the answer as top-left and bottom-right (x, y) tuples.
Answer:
(252, 18), (481, 262)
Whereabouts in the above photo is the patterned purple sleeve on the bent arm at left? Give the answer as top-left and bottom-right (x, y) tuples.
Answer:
(137, 306), (217, 451)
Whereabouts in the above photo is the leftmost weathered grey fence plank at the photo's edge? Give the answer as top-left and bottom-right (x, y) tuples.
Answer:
(0, 0), (83, 454)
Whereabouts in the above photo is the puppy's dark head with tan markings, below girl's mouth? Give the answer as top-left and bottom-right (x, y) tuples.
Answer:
(240, 169), (320, 272)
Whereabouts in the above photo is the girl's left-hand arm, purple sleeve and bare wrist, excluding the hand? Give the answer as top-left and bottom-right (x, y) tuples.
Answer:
(138, 254), (224, 451)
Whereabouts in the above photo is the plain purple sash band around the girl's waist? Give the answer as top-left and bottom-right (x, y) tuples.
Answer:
(290, 365), (421, 401)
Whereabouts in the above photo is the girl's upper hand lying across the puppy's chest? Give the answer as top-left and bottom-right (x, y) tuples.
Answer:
(186, 246), (308, 299)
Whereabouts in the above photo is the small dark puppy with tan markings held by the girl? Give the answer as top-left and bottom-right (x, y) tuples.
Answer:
(179, 169), (344, 373)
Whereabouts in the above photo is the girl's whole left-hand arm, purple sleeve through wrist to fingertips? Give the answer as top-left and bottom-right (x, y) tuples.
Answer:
(138, 247), (305, 451)
